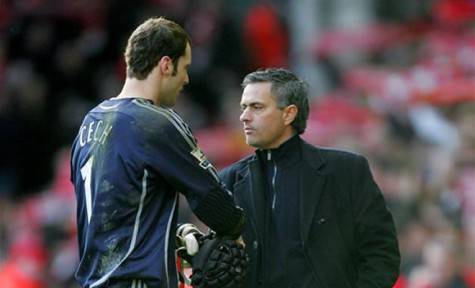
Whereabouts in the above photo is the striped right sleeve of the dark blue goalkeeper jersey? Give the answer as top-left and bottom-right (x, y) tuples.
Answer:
(141, 108), (244, 234)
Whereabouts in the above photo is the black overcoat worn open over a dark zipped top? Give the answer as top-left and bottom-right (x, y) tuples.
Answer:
(220, 141), (400, 288)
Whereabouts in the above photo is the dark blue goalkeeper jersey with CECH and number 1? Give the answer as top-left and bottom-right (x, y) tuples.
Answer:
(71, 98), (241, 287)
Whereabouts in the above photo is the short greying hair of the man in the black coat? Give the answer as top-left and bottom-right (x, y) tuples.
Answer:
(241, 68), (309, 134)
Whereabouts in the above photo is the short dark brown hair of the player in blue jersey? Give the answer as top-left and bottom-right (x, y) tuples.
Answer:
(124, 17), (191, 80)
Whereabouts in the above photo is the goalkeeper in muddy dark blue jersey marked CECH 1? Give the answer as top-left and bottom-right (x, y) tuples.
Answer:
(71, 18), (249, 288)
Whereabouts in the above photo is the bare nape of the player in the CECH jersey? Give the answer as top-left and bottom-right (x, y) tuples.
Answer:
(117, 77), (160, 105)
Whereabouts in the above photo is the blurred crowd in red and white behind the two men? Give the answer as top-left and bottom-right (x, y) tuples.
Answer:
(0, 0), (475, 288)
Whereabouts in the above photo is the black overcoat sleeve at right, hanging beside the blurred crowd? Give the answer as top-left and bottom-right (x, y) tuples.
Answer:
(352, 156), (400, 288)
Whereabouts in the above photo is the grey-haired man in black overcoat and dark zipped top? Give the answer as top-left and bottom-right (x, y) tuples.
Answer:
(220, 69), (400, 288)
